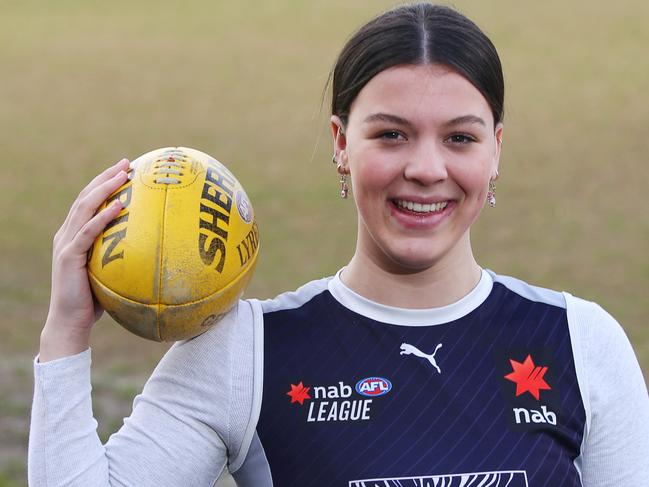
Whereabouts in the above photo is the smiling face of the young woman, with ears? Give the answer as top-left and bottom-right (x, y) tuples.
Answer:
(332, 64), (502, 273)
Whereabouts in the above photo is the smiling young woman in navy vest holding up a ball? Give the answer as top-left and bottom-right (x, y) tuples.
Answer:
(29, 3), (649, 487)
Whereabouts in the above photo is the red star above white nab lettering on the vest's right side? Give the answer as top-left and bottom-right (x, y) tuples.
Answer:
(504, 354), (557, 426)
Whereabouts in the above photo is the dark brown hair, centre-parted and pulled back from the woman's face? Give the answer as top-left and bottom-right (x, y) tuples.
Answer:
(331, 3), (505, 125)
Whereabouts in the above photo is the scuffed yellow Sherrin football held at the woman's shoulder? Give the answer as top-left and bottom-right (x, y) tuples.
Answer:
(88, 147), (259, 341)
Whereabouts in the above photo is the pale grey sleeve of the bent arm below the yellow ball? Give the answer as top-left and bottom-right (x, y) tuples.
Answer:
(28, 303), (252, 487)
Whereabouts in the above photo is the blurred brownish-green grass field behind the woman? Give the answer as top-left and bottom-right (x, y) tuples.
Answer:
(0, 0), (649, 487)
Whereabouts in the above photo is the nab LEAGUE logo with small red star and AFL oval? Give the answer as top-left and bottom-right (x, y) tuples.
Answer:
(286, 377), (392, 423)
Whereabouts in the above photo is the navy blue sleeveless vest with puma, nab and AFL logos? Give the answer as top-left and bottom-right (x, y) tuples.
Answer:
(256, 272), (585, 487)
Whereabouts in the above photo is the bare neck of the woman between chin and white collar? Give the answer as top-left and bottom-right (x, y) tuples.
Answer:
(340, 234), (481, 309)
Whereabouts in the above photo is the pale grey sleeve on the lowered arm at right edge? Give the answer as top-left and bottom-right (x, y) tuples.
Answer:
(572, 298), (649, 487)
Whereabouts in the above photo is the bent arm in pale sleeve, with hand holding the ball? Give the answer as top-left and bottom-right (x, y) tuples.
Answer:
(28, 160), (252, 487)
